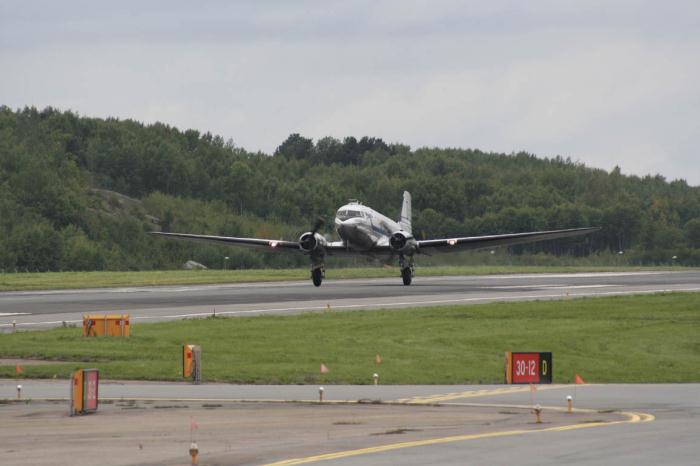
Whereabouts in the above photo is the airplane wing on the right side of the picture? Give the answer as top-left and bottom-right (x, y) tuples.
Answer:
(418, 228), (600, 253)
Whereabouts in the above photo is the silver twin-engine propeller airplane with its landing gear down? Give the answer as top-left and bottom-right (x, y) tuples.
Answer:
(151, 191), (600, 286)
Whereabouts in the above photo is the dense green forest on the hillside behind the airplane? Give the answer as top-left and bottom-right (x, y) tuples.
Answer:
(0, 106), (700, 272)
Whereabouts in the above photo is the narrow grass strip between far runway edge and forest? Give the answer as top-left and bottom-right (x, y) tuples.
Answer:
(0, 265), (682, 291)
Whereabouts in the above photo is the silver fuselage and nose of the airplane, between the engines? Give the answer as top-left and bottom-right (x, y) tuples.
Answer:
(335, 202), (402, 251)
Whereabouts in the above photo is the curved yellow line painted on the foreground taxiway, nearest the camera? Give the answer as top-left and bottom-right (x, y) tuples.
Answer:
(266, 406), (655, 466)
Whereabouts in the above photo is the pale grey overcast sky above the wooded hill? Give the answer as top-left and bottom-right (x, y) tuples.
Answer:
(0, 0), (700, 186)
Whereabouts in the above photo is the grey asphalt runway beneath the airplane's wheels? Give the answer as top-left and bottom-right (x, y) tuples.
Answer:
(0, 270), (700, 331)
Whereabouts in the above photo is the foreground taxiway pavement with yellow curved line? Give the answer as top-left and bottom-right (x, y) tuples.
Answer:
(0, 380), (700, 466)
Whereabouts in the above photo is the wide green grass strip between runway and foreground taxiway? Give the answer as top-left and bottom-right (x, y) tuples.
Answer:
(0, 293), (700, 384)
